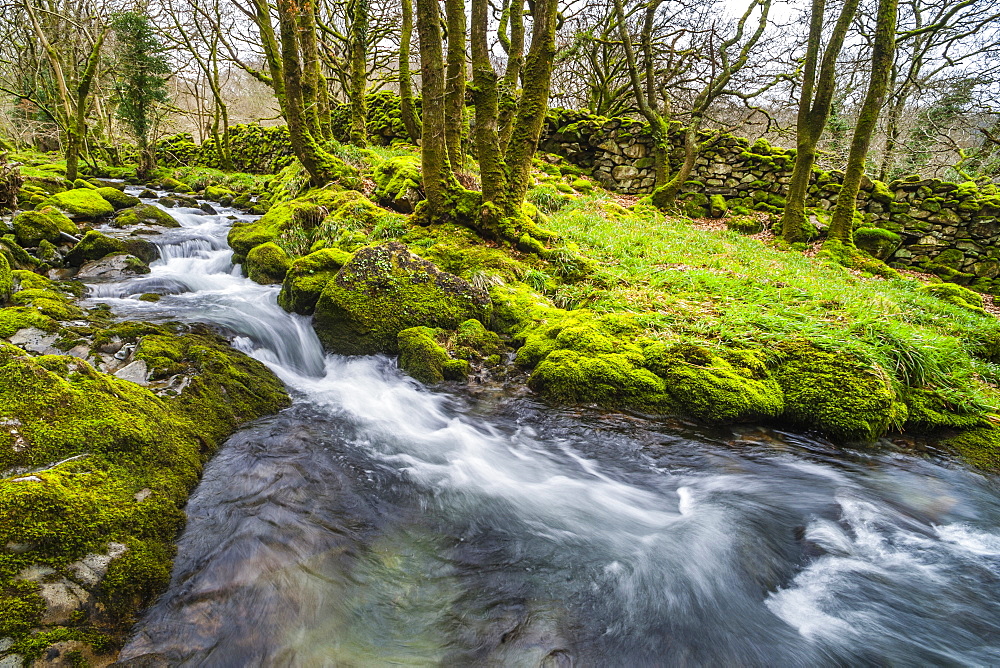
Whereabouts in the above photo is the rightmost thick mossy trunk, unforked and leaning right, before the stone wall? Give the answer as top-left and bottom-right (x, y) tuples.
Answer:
(823, 0), (899, 248)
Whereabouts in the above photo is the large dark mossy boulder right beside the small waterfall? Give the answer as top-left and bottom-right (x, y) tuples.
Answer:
(313, 241), (493, 355)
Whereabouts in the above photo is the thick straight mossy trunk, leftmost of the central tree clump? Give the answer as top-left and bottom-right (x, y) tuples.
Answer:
(416, 0), (457, 223)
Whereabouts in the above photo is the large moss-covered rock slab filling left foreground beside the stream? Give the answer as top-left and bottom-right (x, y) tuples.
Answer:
(0, 332), (289, 654)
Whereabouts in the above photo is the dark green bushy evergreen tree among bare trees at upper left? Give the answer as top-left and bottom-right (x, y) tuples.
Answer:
(112, 12), (170, 176)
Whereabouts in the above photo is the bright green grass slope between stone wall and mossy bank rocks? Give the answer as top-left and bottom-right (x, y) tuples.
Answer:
(550, 194), (1000, 411)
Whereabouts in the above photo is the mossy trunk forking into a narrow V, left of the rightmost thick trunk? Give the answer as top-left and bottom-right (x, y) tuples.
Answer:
(781, 0), (858, 243)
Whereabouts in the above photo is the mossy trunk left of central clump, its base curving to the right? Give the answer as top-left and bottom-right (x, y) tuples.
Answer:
(278, 0), (346, 186)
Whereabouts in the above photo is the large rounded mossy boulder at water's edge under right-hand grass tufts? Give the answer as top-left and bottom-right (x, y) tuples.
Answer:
(773, 340), (906, 441)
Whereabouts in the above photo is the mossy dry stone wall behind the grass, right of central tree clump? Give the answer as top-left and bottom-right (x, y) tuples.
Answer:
(539, 109), (1000, 294)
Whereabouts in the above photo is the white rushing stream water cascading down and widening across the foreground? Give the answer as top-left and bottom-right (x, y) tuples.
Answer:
(82, 190), (1000, 666)
